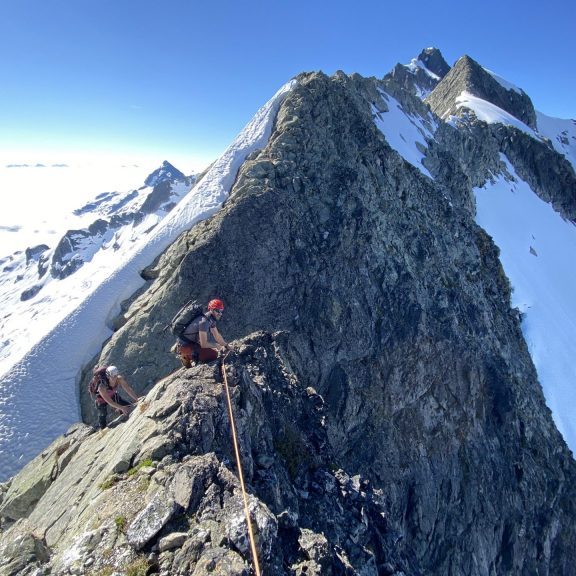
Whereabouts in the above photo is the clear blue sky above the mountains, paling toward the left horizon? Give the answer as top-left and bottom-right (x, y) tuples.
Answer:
(0, 0), (576, 171)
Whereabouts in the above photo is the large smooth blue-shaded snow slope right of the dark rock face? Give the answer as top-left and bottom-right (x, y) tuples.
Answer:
(475, 156), (576, 454)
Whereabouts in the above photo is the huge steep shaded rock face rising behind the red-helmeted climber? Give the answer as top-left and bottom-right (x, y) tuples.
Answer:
(76, 74), (576, 575)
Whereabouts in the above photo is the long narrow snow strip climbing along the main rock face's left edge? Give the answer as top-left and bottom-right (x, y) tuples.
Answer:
(0, 81), (296, 480)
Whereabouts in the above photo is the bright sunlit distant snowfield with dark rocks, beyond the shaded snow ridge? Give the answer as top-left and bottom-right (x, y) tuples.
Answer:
(0, 181), (191, 378)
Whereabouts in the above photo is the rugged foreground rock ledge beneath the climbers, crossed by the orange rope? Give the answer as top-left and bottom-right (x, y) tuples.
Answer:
(0, 333), (419, 576)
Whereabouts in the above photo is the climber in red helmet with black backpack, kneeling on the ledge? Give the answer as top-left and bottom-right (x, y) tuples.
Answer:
(178, 298), (230, 368)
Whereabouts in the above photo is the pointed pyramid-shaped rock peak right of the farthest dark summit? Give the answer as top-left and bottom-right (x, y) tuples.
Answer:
(426, 56), (536, 128)
